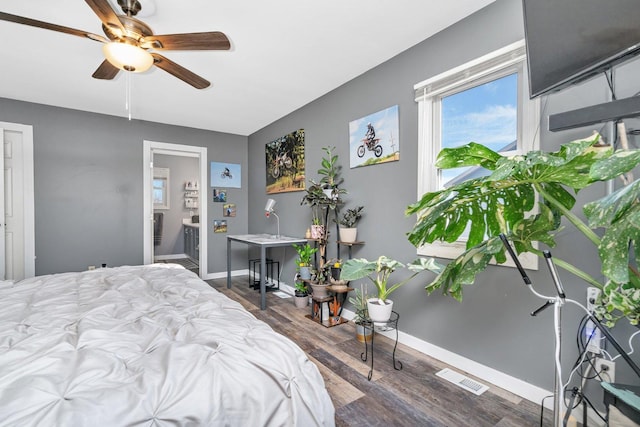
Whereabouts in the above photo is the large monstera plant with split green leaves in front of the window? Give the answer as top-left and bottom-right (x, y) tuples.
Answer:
(406, 134), (640, 326)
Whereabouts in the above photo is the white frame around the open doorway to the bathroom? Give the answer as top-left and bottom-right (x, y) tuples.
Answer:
(142, 140), (209, 278)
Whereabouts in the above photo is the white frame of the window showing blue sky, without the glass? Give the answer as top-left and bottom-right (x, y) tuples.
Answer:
(414, 40), (540, 269)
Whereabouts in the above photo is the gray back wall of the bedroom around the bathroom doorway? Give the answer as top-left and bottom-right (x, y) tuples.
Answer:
(0, 98), (247, 275)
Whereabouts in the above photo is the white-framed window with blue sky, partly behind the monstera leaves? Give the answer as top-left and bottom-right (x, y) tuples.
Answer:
(414, 41), (540, 268)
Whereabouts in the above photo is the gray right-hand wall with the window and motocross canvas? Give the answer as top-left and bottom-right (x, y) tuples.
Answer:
(249, 0), (639, 400)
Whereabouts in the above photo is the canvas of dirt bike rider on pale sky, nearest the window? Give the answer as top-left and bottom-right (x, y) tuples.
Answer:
(349, 105), (400, 169)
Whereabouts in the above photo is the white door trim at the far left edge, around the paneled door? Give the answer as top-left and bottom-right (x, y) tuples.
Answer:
(0, 122), (36, 279)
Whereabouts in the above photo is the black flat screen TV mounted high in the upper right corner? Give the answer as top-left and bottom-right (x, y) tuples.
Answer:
(522, 0), (640, 98)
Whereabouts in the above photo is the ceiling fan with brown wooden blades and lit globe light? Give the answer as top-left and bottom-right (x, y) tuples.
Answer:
(0, 0), (231, 89)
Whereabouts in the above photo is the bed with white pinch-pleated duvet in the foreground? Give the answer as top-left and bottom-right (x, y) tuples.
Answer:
(0, 264), (334, 426)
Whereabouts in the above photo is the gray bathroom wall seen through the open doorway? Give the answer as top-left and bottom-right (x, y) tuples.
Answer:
(153, 154), (199, 257)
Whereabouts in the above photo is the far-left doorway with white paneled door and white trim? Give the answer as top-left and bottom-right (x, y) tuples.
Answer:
(0, 122), (36, 280)
